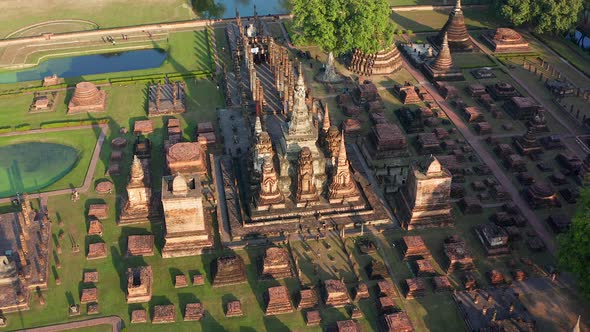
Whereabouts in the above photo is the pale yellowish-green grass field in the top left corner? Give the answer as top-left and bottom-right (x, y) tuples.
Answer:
(0, 0), (195, 38)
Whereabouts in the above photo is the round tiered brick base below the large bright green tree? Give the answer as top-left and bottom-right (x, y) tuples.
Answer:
(348, 45), (403, 76)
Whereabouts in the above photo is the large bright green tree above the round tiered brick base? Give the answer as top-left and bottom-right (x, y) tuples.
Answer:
(292, 0), (394, 55)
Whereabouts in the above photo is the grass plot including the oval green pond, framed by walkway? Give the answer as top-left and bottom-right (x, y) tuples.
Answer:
(0, 129), (98, 197)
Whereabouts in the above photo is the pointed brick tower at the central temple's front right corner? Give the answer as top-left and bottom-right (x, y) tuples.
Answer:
(328, 133), (360, 204)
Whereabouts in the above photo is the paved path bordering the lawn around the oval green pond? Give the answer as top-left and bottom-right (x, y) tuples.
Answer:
(0, 124), (109, 204)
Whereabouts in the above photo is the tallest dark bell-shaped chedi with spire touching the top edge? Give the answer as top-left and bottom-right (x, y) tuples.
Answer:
(431, 0), (473, 52)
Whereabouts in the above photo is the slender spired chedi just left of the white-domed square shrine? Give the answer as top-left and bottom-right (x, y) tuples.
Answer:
(119, 156), (152, 224)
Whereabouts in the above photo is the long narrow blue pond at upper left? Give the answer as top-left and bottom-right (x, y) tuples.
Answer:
(0, 49), (166, 83)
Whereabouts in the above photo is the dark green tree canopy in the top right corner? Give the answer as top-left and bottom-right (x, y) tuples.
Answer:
(498, 0), (585, 33)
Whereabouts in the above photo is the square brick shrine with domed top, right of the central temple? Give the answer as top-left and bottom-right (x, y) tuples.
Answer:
(396, 157), (453, 230)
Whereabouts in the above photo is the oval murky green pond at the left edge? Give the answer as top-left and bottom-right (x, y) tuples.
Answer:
(0, 142), (79, 197)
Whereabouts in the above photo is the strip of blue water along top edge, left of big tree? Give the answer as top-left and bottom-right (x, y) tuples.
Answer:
(192, 0), (289, 18)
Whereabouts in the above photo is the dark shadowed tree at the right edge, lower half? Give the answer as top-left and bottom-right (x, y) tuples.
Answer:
(557, 188), (590, 297)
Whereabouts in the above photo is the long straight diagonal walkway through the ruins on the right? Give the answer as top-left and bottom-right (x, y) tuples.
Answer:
(404, 59), (555, 252)
